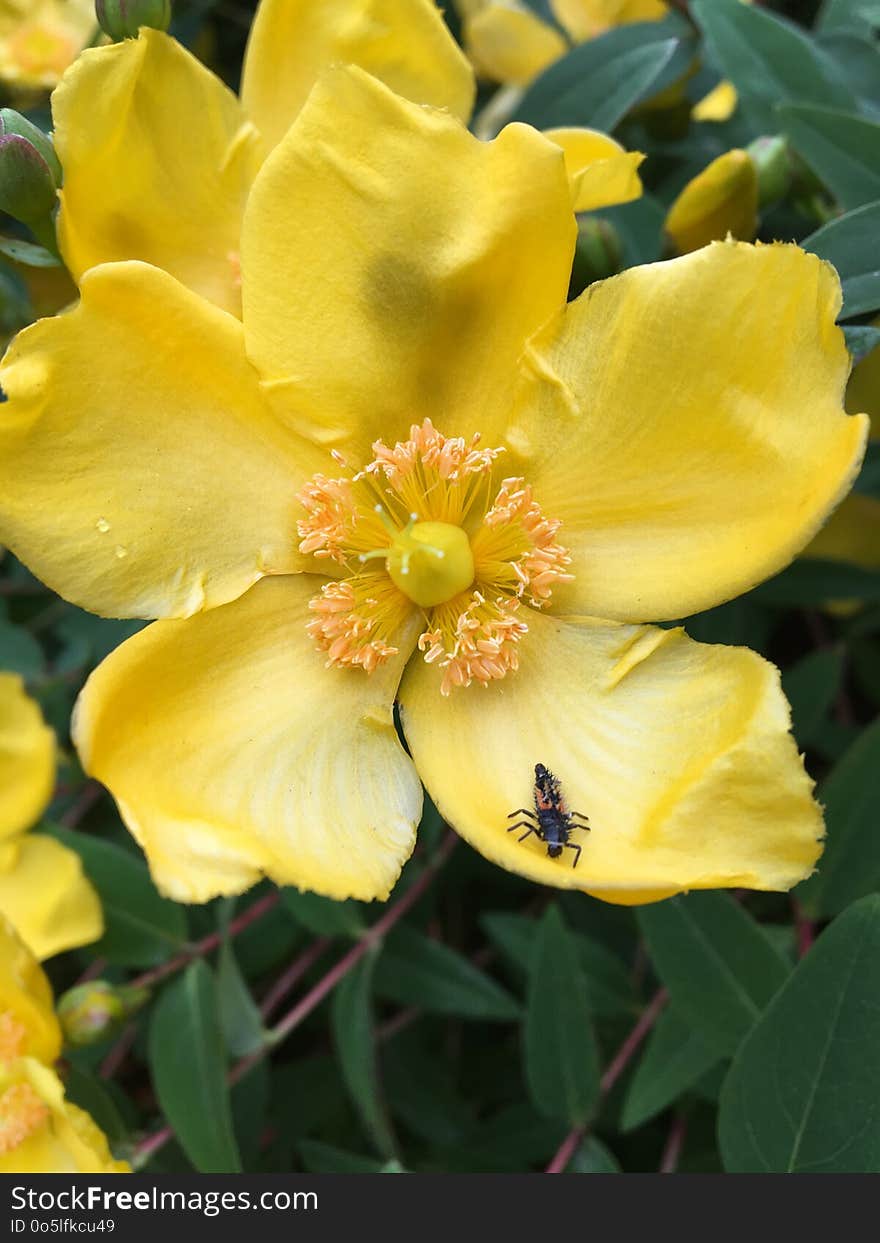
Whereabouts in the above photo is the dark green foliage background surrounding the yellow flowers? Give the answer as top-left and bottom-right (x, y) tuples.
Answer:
(0, 0), (880, 1173)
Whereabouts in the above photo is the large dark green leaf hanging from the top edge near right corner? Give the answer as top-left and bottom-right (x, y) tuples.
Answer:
(691, 0), (855, 133)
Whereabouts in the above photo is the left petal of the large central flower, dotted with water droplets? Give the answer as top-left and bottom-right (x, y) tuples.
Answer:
(0, 264), (326, 618)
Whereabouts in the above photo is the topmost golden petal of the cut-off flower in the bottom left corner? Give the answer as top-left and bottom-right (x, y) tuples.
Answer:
(0, 915), (62, 1064)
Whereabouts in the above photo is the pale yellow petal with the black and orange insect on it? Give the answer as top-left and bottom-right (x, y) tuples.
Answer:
(400, 614), (823, 904)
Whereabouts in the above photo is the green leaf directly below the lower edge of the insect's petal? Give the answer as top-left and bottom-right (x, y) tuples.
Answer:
(636, 891), (789, 1055)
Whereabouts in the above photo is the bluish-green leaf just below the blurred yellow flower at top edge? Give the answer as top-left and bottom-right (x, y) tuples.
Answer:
(513, 21), (692, 133)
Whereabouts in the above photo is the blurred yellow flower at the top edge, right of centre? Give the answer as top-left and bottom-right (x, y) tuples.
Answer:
(460, 0), (670, 86)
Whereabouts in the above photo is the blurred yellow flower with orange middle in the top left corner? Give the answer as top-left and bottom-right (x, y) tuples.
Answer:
(0, 0), (97, 91)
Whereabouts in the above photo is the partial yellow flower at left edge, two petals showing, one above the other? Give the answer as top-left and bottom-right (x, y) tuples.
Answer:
(0, 674), (103, 958)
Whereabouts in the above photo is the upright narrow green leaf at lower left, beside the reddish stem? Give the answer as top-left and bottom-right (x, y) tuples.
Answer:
(149, 961), (241, 1173)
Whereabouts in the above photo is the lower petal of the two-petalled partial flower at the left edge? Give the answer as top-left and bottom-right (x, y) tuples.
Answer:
(0, 833), (104, 958)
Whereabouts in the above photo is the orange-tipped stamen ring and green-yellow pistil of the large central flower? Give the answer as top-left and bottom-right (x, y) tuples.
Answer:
(297, 419), (572, 695)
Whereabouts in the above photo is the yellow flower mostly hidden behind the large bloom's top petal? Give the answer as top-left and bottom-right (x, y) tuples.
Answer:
(52, 0), (641, 316)
